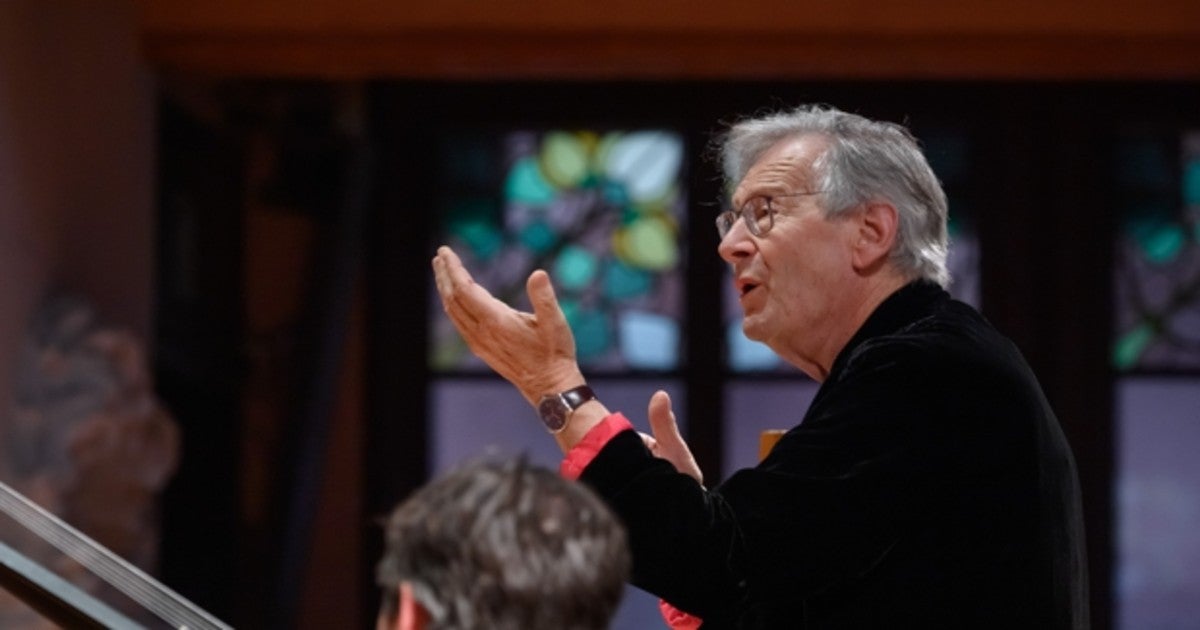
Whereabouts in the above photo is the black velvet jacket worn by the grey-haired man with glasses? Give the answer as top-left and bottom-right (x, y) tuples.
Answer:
(581, 282), (1087, 629)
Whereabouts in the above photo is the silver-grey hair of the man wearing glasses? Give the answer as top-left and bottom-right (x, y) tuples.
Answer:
(715, 104), (950, 287)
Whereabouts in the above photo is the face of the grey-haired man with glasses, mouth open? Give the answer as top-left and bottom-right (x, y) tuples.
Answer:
(718, 136), (853, 373)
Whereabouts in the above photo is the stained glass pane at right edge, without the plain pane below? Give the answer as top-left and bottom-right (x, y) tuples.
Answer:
(1112, 132), (1200, 371)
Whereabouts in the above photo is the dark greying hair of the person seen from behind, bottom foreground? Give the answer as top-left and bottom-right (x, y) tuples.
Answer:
(376, 457), (630, 630)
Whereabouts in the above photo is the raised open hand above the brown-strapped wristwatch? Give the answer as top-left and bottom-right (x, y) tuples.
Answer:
(433, 246), (583, 404)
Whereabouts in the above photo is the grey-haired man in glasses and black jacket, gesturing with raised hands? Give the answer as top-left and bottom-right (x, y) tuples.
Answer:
(433, 107), (1087, 629)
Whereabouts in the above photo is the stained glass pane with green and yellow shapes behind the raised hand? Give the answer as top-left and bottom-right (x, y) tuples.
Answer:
(430, 130), (686, 373)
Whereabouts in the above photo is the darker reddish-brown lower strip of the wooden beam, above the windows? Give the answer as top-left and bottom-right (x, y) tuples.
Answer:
(143, 31), (1200, 80)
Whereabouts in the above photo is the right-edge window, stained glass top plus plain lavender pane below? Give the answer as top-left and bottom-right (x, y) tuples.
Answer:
(1112, 126), (1200, 629)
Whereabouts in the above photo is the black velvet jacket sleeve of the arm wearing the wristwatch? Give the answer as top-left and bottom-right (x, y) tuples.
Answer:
(581, 338), (955, 622)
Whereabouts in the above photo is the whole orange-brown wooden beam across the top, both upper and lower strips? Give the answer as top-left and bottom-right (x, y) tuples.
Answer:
(139, 0), (1200, 79)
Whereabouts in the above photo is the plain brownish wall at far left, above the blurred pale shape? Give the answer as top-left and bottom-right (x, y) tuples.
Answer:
(0, 0), (154, 410)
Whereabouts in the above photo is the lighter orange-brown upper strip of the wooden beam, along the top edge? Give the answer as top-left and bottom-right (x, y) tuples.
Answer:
(138, 0), (1200, 34)
